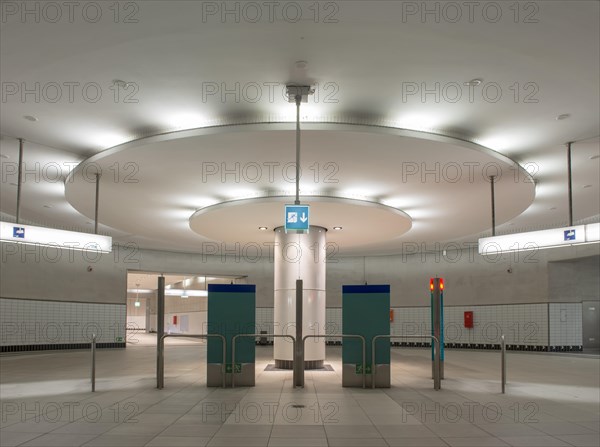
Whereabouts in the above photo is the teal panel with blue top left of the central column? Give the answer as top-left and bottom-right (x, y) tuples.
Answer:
(206, 284), (256, 386)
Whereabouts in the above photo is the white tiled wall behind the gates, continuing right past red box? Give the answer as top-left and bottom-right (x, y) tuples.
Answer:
(256, 303), (582, 346)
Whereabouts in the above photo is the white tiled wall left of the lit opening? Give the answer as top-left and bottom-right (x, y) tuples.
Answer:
(0, 298), (126, 346)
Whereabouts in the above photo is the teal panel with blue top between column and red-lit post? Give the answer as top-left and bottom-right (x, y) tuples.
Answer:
(342, 285), (390, 388)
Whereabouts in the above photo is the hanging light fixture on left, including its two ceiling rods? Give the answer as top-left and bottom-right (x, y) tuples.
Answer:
(0, 138), (112, 253)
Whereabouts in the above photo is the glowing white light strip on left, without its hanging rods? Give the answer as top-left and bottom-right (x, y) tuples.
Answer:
(0, 222), (112, 253)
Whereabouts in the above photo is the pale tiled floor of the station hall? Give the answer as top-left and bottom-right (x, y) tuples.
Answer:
(0, 339), (600, 447)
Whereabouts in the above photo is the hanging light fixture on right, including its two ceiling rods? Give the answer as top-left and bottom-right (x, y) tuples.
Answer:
(479, 143), (600, 255)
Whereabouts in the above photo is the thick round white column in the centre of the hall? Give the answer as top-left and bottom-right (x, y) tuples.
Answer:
(273, 226), (327, 369)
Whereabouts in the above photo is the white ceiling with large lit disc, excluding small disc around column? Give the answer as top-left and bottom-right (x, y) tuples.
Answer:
(0, 1), (600, 253)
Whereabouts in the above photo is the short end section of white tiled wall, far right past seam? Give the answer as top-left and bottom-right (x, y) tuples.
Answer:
(549, 303), (583, 346)
